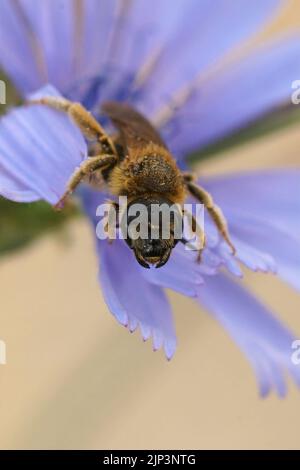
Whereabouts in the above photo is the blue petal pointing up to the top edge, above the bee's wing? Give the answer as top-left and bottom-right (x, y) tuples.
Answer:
(89, 0), (199, 107)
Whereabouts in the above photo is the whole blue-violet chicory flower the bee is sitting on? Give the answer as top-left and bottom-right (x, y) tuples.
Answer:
(0, 0), (300, 395)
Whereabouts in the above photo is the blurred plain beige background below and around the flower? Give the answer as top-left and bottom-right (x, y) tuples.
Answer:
(0, 0), (300, 449)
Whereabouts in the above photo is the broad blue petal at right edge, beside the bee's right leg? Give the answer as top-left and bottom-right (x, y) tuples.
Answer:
(205, 169), (300, 289)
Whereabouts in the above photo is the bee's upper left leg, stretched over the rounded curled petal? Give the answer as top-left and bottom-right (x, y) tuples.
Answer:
(27, 96), (117, 156)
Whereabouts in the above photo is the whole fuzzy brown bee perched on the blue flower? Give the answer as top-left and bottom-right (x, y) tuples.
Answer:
(29, 96), (235, 268)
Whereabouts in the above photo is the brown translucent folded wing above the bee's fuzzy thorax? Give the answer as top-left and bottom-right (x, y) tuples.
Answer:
(102, 101), (167, 154)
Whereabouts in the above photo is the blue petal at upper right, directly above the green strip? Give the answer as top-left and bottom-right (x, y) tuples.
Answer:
(162, 37), (300, 156)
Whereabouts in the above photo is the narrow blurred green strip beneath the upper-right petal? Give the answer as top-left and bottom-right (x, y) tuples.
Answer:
(188, 105), (300, 164)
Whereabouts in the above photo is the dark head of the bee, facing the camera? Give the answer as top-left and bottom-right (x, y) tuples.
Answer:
(121, 197), (182, 268)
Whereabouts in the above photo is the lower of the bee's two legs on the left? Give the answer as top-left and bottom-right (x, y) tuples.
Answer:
(55, 155), (117, 209)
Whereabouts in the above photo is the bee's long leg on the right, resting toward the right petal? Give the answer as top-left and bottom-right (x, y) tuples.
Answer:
(183, 173), (236, 255)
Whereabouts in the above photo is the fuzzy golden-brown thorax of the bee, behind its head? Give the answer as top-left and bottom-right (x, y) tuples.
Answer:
(109, 144), (185, 204)
